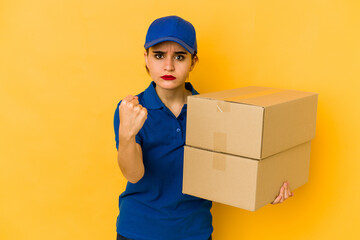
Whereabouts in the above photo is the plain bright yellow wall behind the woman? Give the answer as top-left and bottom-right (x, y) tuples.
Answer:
(0, 0), (360, 240)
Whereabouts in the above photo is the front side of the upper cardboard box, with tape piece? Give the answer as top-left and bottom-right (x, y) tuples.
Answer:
(186, 95), (264, 159)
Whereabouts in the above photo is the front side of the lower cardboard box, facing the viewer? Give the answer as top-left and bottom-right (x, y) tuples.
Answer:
(183, 146), (259, 211)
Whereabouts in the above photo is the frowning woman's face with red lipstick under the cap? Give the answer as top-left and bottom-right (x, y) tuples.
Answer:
(144, 41), (197, 90)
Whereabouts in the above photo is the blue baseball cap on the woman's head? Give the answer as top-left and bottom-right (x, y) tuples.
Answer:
(144, 16), (197, 54)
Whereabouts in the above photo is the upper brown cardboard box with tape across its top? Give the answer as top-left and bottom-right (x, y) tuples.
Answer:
(186, 87), (317, 159)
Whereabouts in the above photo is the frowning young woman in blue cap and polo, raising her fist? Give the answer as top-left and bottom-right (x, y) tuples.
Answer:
(114, 16), (292, 240)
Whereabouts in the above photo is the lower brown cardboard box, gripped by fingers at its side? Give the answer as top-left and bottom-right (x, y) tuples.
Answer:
(183, 142), (310, 211)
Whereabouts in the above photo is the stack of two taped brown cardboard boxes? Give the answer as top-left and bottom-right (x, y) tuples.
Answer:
(183, 87), (318, 211)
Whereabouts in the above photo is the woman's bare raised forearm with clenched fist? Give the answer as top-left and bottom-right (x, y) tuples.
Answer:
(117, 95), (147, 183)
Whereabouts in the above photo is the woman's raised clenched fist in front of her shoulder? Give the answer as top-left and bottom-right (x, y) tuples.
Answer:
(119, 95), (147, 139)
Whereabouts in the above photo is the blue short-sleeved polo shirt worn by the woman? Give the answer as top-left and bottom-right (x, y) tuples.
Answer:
(114, 82), (213, 240)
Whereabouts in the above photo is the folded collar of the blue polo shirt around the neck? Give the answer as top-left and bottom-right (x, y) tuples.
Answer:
(144, 81), (199, 109)
